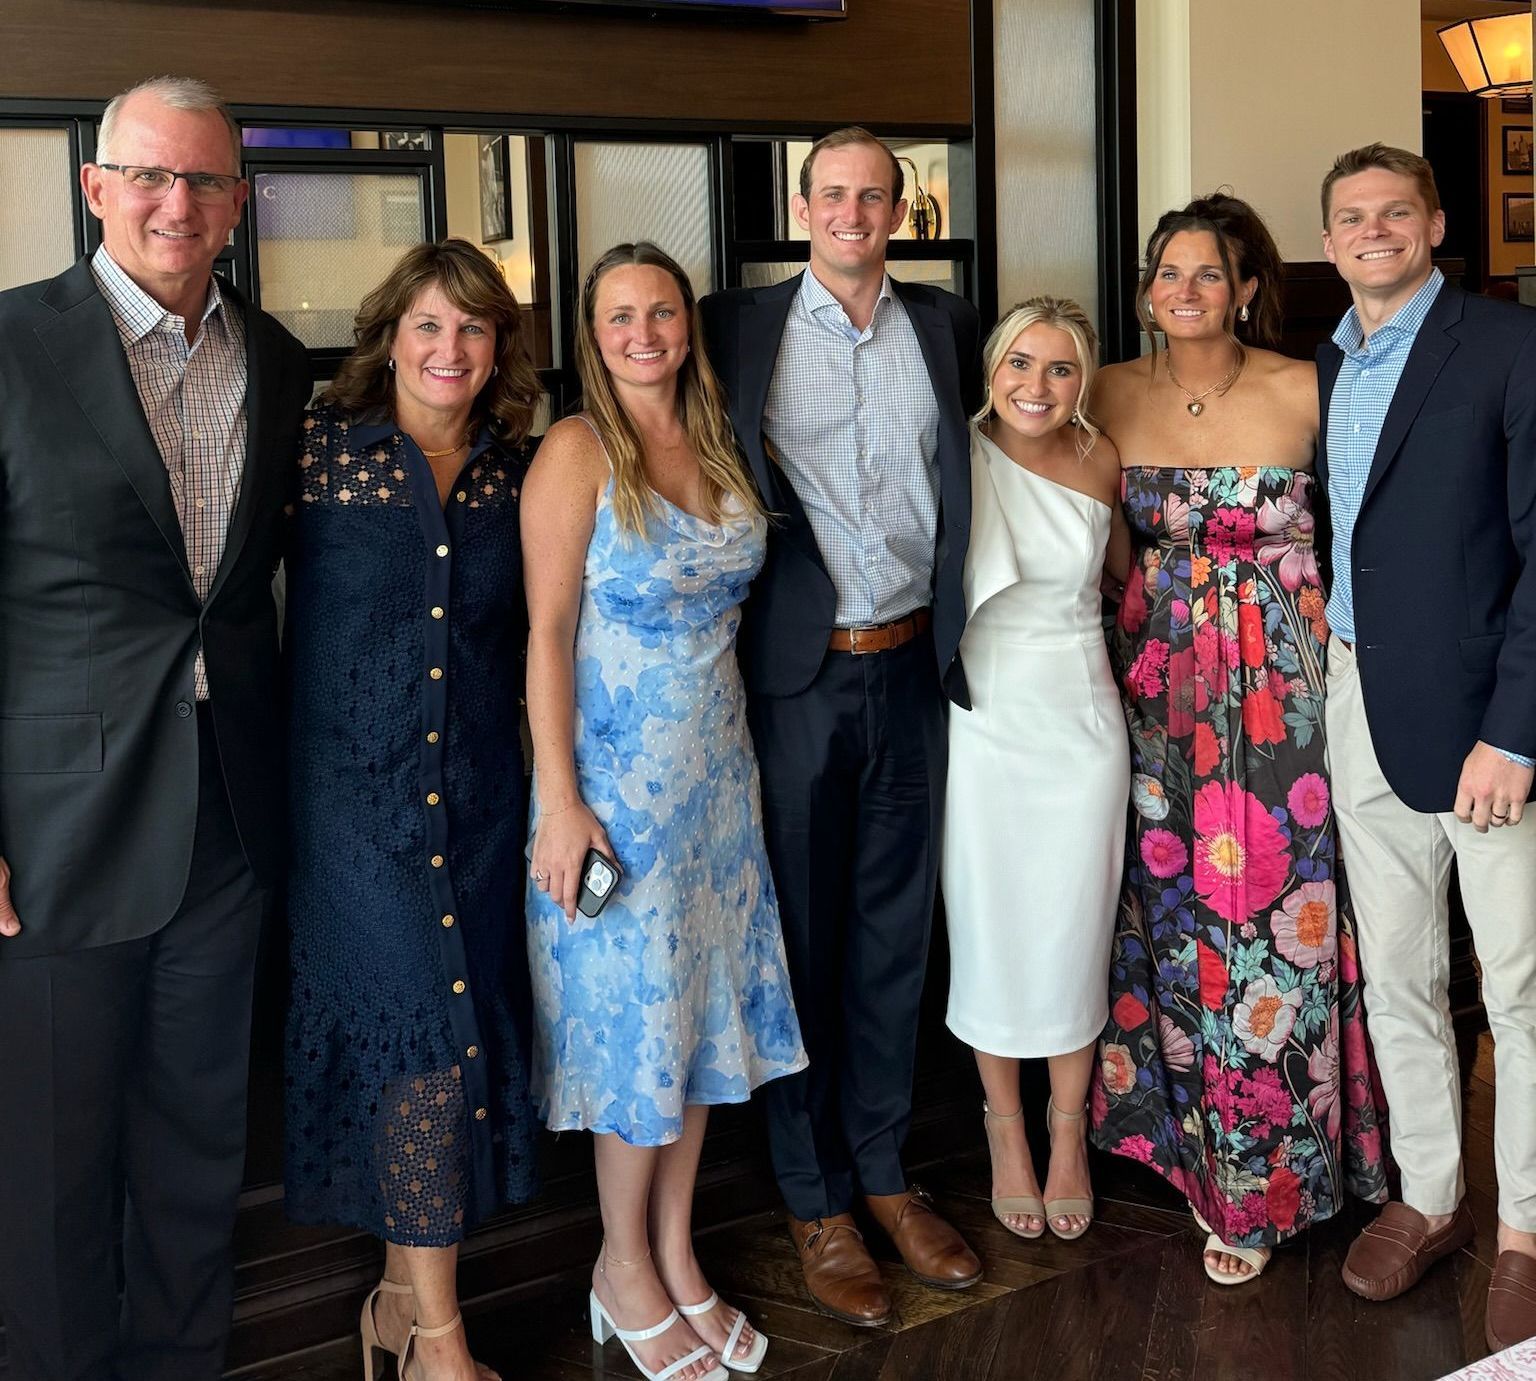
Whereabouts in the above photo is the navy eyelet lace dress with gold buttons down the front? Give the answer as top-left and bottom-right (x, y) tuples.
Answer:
(286, 407), (535, 1246)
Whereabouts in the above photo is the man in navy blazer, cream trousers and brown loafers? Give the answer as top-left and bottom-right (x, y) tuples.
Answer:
(1318, 144), (1536, 1349)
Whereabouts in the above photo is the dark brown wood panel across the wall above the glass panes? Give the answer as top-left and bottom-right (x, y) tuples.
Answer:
(0, 0), (971, 132)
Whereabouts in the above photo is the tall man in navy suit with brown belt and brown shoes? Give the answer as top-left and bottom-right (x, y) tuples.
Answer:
(702, 128), (982, 1326)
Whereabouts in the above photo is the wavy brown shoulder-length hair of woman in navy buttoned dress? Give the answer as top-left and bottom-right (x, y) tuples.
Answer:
(321, 240), (541, 444)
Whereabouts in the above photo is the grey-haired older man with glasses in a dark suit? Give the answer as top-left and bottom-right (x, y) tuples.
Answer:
(0, 78), (310, 1381)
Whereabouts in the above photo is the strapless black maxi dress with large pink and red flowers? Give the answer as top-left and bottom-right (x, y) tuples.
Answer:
(1092, 465), (1385, 1247)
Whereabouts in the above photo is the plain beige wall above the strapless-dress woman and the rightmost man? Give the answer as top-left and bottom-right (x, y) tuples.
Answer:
(1137, 0), (1422, 260)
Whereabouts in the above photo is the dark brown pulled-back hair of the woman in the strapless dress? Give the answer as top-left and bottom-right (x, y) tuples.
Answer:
(1137, 192), (1286, 366)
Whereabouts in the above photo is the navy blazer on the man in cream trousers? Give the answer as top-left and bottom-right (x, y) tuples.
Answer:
(1318, 284), (1536, 811)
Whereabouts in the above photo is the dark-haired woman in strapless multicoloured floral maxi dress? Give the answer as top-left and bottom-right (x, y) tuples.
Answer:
(1094, 194), (1385, 1284)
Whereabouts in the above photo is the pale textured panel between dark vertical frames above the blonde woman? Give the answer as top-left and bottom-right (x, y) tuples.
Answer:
(982, 0), (1100, 316)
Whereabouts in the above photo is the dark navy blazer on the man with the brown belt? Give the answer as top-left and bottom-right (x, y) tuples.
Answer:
(699, 273), (982, 708)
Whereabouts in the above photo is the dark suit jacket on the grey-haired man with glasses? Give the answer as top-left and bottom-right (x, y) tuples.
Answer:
(0, 260), (310, 962)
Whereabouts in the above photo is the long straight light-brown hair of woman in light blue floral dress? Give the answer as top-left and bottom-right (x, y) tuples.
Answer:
(576, 240), (763, 535)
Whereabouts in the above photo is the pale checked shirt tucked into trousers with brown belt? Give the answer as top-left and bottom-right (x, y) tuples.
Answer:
(763, 269), (938, 628)
